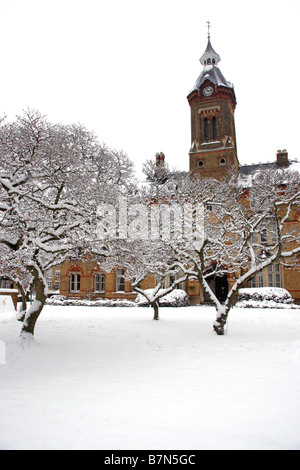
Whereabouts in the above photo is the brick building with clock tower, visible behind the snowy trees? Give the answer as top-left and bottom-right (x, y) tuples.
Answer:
(55, 35), (300, 304)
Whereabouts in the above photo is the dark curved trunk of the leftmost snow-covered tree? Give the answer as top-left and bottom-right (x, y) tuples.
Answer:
(20, 268), (47, 343)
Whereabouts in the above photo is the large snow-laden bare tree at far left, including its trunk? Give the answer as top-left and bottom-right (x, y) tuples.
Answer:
(0, 110), (134, 340)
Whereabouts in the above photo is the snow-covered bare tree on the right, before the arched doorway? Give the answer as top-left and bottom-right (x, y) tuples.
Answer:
(173, 170), (300, 335)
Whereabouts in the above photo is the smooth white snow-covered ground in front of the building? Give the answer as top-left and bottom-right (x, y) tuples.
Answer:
(0, 305), (300, 450)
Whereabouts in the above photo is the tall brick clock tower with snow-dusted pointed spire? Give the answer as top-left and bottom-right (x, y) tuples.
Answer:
(187, 32), (239, 178)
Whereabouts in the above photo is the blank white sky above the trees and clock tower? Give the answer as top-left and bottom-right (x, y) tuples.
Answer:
(0, 0), (300, 178)
